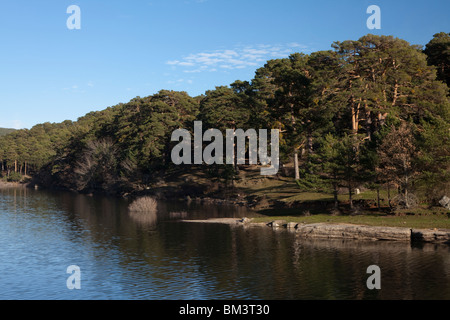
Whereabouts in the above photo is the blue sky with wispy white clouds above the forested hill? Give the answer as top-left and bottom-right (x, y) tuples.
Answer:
(0, 0), (450, 128)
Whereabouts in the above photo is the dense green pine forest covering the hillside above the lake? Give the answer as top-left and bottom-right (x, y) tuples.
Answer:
(0, 32), (450, 208)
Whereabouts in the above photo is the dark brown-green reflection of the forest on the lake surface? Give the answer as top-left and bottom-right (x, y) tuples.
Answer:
(7, 190), (450, 299)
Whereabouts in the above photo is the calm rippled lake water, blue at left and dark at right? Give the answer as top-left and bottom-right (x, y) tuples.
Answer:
(0, 189), (450, 300)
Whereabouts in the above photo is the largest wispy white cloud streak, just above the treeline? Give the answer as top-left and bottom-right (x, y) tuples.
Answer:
(167, 42), (307, 73)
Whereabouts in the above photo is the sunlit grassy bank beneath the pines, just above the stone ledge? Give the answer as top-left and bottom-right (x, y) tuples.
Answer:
(210, 165), (450, 229)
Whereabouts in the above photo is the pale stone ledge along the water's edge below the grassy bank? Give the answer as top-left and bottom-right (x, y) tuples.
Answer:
(181, 218), (450, 245)
